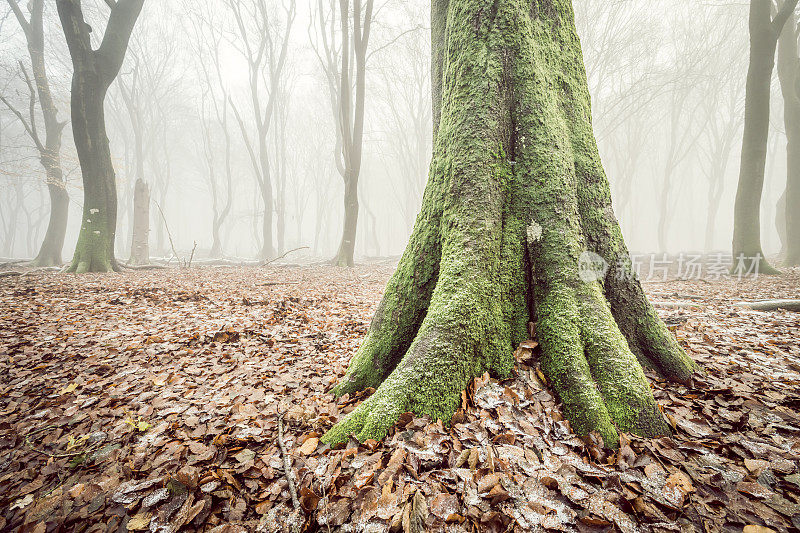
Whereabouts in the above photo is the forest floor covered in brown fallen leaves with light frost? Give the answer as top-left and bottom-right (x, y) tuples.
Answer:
(0, 264), (800, 533)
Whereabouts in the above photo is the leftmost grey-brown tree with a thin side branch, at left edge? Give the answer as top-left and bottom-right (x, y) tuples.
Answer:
(0, 0), (69, 266)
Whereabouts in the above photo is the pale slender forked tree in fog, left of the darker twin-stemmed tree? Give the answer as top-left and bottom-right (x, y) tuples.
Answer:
(228, 0), (296, 260)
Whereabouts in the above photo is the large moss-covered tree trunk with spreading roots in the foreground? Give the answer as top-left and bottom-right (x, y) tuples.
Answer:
(324, 0), (694, 446)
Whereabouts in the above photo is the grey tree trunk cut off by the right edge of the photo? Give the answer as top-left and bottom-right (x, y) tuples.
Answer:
(776, 13), (800, 266)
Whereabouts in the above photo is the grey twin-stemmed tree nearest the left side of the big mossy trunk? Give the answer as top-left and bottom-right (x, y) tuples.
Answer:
(315, 0), (373, 266)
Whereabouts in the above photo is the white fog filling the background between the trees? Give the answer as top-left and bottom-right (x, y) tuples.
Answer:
(0, 0), (786, 261)
